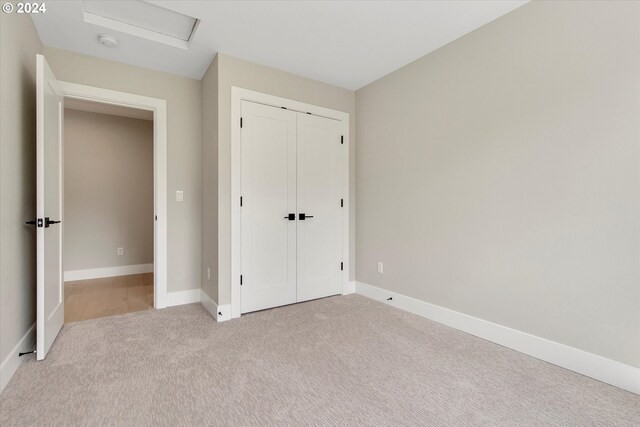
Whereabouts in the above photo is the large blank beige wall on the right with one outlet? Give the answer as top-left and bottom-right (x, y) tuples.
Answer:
(356, 2), (640, 367)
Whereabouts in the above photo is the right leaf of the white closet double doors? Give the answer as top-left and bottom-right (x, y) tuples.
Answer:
(297, 114), (346, 301)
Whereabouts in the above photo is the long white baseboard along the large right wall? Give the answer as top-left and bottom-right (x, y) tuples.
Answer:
(356, 282), (640, 394)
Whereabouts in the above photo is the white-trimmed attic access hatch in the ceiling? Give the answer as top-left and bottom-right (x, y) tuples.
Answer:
(82, 0), (200, 49)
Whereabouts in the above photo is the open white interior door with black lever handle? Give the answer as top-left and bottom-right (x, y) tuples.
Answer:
(36, 55), (64, 360)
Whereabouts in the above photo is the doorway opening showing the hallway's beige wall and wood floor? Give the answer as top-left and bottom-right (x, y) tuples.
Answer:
(63, 98), (154, 323)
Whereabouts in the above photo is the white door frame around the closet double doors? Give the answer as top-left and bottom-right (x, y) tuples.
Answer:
(231, 86), (353, 318)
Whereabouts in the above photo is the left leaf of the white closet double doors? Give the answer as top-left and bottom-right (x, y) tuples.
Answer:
(241, 101), (297, 313)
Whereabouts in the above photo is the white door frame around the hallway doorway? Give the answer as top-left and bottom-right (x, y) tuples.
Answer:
(59, 81), (168, 308)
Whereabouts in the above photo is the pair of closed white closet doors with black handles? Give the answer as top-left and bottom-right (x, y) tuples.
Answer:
(241, 101), (345, 313)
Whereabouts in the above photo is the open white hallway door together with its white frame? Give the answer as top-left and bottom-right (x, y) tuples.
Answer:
(36, 54), (168, 360)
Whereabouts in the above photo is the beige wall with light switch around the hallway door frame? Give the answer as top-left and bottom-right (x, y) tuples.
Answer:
(44, 47), (202, 292)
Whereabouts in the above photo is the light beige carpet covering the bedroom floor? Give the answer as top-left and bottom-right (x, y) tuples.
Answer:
(0, 295), (640, 427)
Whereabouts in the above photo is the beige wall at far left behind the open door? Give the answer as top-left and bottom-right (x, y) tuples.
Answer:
(0, 9), (42, 379)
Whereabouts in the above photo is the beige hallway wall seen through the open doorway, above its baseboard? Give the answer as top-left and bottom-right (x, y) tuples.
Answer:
(64, 109), (154, 271)
